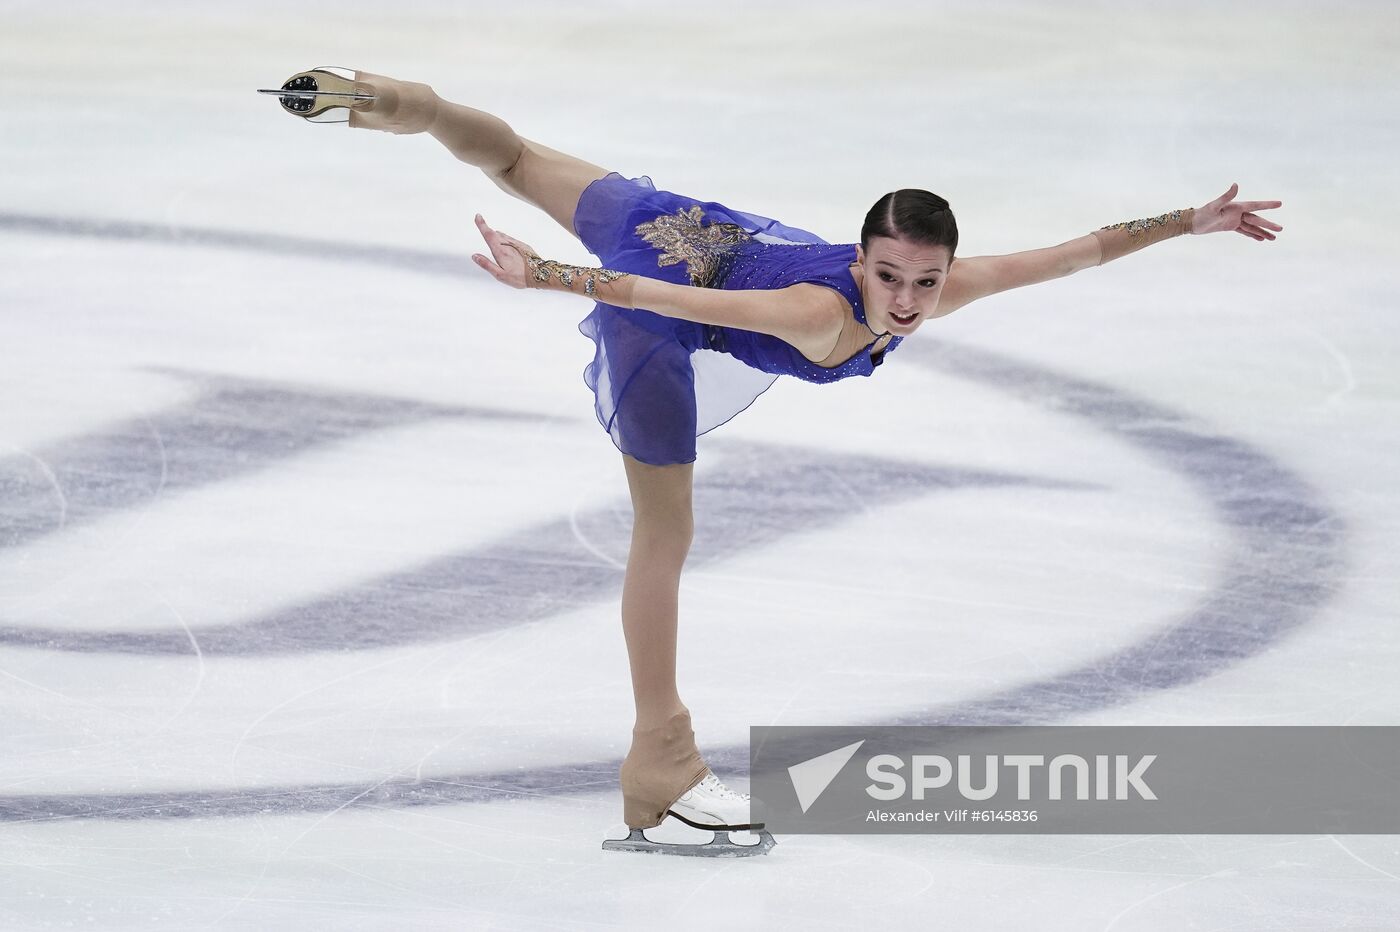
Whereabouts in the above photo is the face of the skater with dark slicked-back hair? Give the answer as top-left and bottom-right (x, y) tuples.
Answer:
(855, 236), (953, 337)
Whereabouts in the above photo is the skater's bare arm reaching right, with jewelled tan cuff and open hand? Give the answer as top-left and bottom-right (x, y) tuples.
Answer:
(938, 185), (1284, 313)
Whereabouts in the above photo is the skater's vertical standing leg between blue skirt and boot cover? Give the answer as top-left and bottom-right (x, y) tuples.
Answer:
(622, 455), (694, 729)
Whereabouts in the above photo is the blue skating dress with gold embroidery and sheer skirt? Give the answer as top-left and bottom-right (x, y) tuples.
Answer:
(574, 172), (900, 466)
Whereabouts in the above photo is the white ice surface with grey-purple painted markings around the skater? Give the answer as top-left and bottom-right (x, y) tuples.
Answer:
(0, 0), (1400, 932)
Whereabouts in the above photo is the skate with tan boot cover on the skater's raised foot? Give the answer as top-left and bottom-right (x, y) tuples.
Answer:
(258, 66), (440, 133)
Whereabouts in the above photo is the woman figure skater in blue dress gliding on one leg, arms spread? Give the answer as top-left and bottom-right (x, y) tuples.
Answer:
(266, 69), (1282, 856)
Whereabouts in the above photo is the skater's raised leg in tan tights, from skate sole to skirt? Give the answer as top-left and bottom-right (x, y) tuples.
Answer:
(350, 71), (608, 235)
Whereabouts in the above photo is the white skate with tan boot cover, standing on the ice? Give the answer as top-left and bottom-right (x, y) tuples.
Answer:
(603, 712), (777, 858)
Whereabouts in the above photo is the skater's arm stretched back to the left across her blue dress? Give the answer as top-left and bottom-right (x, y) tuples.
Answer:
(472, 214), (840, 346)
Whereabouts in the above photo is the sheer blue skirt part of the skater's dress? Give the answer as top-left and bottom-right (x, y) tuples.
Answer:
(574, 172), (825, 466)
